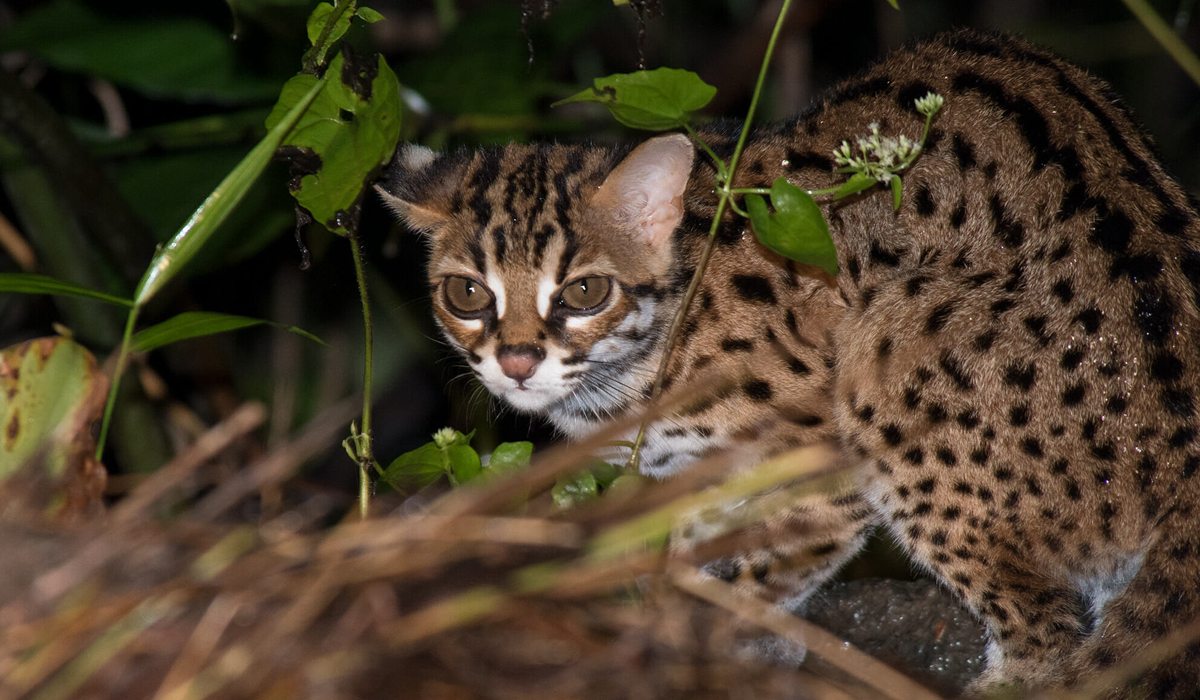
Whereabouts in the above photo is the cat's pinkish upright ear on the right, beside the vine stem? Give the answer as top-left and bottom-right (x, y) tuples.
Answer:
(592, 133), (696, 250)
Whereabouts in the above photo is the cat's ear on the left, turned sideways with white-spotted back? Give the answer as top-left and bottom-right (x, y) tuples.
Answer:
(376, 143), (462, 233)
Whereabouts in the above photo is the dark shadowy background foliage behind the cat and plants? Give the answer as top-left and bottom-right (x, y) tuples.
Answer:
(0, 0), (1200, 503)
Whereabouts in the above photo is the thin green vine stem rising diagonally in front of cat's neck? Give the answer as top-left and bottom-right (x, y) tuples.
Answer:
(629, 0), (792, 471)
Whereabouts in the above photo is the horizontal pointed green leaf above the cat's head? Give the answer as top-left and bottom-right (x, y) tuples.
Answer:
(554, 68), (716, 131)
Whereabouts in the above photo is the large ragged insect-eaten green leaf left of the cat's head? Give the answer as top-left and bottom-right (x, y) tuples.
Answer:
(266, 53), (401, 235)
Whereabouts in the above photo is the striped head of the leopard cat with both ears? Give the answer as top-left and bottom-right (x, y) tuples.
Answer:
(377, 134), (695, 413)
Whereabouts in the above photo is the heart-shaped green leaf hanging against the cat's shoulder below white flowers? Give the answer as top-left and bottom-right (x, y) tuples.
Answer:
(746, 178), (838, 275)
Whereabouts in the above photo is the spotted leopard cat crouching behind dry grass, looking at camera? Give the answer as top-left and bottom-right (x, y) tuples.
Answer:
(379, 31), (1200, 698)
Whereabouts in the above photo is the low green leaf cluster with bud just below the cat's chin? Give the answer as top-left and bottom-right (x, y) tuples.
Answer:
(379, 427), (533, 493)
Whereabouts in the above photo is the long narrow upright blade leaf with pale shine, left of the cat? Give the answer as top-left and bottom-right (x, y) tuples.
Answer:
(133, 78), (325, 306)
